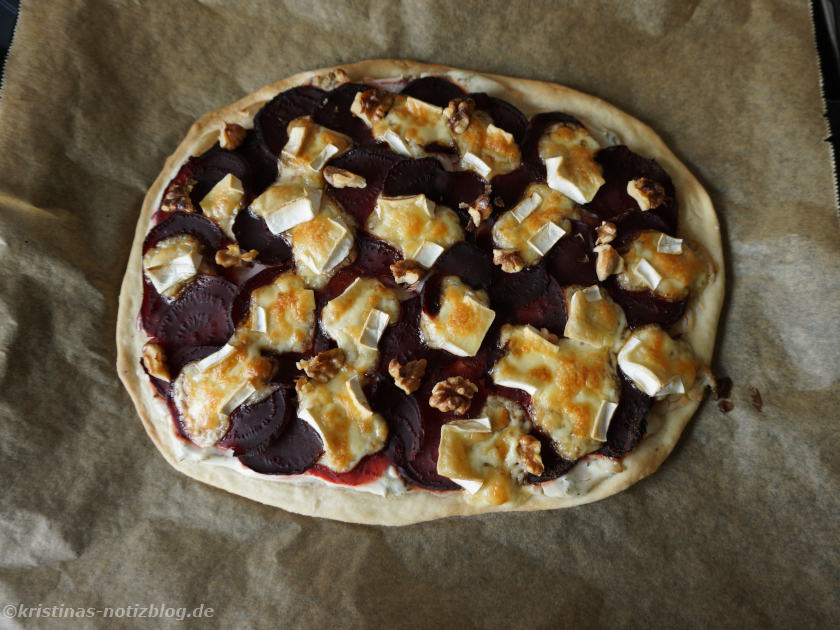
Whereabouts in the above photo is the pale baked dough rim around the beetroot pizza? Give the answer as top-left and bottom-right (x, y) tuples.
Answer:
(116, 59), (724, 525)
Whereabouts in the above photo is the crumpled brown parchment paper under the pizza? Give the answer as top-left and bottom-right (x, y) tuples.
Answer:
(0, 0), (840, 628)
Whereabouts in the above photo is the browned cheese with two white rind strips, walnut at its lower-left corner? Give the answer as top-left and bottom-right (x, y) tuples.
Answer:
(493, 184), (580, 265)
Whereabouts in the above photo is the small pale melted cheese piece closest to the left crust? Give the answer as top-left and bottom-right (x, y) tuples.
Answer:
(143, 234), (203, 298)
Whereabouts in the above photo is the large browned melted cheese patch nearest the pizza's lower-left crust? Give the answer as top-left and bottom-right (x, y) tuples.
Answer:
(172, 332), (274, 448)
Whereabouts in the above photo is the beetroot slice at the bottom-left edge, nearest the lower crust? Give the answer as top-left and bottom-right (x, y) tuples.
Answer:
(239, 414), (324, 475)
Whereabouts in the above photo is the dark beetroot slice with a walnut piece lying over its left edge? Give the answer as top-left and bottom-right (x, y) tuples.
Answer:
(327, 148), (405, 225)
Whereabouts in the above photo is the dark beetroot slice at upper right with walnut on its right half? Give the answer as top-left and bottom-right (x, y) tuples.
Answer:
(585, 145), (678, 234)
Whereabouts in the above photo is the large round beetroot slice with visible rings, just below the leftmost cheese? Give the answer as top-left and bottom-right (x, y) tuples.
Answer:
(153, 276), (236, 354)
